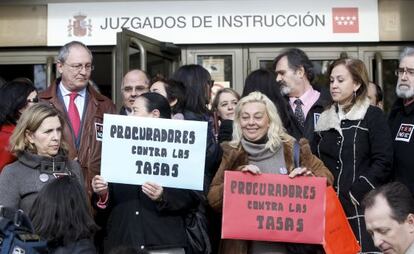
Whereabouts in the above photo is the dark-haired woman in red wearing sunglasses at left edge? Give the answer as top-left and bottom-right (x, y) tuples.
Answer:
(0, 78), (38, 172)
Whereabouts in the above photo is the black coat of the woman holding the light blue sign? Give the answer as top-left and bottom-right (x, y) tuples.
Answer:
(99, 183), (199, 253)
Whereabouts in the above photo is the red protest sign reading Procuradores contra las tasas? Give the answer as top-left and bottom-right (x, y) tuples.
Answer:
(222, 171), (326, 244)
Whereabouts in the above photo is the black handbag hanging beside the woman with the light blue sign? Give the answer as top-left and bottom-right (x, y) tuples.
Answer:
(184, 194), (211, 254)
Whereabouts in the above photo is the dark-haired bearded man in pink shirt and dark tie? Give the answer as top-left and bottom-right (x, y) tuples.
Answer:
(273, 48), (331, 141)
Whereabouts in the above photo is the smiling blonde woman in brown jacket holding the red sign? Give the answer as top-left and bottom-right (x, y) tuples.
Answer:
(208, 92), (333, 254)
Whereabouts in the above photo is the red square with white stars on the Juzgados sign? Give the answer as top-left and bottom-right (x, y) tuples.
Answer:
(332, 8), (359, 33)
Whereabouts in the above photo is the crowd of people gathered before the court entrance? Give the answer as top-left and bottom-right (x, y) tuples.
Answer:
(0, 41), (414, 254)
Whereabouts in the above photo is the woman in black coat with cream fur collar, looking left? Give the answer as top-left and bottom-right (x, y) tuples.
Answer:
(312, 58), (393, 253)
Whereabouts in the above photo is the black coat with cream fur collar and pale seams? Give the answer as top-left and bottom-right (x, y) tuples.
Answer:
(313, 99), (392, 253)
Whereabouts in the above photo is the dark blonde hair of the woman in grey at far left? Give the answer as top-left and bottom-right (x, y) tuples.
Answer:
(10, 103), (68, 155)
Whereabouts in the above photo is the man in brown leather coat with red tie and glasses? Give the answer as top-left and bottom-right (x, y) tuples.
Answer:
(39, 41), (116, 195)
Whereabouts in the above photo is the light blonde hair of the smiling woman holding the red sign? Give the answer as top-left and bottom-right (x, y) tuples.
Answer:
(229, 92), (293, 152)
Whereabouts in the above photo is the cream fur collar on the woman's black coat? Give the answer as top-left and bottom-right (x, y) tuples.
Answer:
(315, 98), (369, 135)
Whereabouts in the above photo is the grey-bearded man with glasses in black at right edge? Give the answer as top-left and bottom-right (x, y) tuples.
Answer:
(388, 47), (414, 194)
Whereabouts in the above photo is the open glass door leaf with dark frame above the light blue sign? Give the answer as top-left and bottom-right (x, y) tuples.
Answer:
(113, 29), (181, 107)
